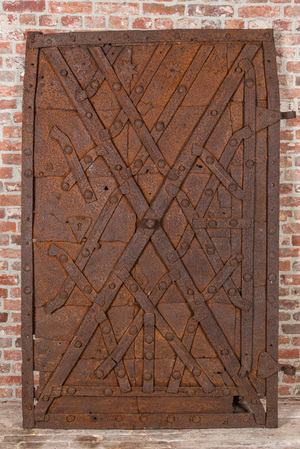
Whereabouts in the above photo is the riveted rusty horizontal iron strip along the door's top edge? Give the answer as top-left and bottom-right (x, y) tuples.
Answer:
(27, 29), (273, 48)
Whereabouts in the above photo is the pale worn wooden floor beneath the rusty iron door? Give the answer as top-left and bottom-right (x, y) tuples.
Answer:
(0, 401), (300, 449)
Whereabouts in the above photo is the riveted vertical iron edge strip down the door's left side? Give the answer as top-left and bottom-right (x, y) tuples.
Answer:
(21, 39), (39, 428)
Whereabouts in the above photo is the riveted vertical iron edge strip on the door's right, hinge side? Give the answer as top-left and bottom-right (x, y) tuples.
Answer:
(263, 42), (280, 427)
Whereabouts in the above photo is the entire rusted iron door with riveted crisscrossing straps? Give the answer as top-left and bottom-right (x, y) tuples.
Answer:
(22, 30), (285, 428)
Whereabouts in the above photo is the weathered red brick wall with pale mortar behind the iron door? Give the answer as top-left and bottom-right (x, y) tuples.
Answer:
(0, 0), (300, 401)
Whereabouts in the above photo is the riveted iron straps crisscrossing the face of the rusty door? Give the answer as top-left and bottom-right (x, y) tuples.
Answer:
(35, 39), (280, 424)
